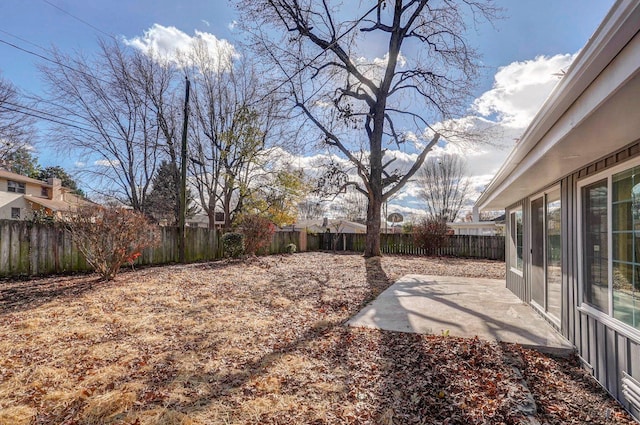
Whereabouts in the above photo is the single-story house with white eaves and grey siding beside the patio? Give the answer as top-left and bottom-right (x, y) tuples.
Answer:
(476, 0), (640, 419)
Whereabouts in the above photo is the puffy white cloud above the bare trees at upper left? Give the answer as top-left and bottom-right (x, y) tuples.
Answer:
(123, 24), (238, 70)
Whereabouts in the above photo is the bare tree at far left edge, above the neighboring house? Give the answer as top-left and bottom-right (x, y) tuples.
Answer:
(0, 76), (35, 164)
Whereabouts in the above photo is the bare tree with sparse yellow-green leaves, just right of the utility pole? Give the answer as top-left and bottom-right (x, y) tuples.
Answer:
(191, 49), (280, 229)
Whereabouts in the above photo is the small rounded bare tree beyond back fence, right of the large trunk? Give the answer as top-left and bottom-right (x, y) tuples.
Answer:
(417, 154), (469, 222)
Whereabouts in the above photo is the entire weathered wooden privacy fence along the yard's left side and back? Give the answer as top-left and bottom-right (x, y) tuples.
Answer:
(0, 220), (504, 277)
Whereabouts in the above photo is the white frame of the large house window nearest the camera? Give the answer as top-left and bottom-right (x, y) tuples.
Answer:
(576, 158), (640, 344)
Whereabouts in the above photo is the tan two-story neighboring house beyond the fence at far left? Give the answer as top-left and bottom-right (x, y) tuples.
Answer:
(0, 169), (91, 220)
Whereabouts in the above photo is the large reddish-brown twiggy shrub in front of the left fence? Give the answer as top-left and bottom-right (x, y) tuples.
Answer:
(64, 206), (159, 280)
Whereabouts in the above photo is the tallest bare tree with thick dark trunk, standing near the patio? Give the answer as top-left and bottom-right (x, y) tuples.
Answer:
(238, 0), (496, 256)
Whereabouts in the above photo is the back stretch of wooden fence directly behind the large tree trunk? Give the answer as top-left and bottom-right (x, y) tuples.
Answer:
(316, 233), (505, 261)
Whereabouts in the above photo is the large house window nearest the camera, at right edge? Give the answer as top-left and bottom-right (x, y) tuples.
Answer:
(580, 162), (640, 330)
